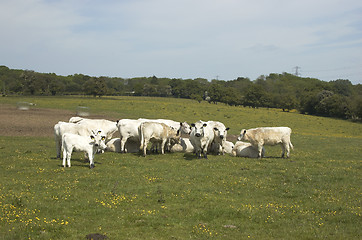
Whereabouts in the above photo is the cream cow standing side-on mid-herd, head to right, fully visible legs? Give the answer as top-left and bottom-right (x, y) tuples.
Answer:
(139, 122), (180, 156)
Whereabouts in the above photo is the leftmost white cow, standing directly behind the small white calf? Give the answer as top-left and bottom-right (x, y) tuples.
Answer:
(54, 121), (94, 158)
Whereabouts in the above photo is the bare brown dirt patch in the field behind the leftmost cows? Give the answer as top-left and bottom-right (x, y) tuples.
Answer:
(0, 104), (106, 137)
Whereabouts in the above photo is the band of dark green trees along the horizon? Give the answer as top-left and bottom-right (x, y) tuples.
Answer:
(0, 66), (362, 121)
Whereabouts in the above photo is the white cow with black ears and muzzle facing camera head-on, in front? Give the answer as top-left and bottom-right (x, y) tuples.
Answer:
(190, 120), (214, 159)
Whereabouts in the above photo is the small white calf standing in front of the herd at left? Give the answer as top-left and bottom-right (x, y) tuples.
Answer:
(62, 131), (107, 168)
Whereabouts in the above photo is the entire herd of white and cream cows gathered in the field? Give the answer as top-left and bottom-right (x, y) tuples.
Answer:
(54, 117), (293, 168)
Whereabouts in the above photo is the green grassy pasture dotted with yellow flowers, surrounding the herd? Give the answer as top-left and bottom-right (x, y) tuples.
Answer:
(0, 97), (362, 239)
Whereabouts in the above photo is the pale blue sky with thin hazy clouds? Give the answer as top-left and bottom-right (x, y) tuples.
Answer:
(0, 0), (362, 84)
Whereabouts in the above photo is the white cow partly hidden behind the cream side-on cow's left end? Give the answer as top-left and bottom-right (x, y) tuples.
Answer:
(117, 119), (144, 153)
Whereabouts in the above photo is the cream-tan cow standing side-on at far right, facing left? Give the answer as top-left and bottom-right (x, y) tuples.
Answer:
(238, 127), (293, 158)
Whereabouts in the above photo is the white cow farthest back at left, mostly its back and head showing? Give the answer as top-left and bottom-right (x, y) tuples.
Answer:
(69, 117), (118, 141)
